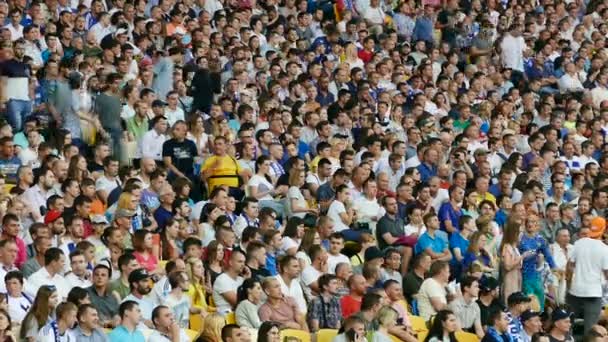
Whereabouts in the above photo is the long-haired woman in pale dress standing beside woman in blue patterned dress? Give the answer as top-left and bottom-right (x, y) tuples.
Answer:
(500, 219), (522, 304)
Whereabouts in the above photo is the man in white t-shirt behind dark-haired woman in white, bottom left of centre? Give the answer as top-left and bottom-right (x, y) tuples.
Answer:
(213, 250), (249, 316)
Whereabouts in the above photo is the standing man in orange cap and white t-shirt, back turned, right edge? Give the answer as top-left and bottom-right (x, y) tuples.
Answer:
(566, 226), (608, 332)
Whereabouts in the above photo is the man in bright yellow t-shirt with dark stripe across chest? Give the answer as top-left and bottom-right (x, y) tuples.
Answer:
(201, 136), (244, 200)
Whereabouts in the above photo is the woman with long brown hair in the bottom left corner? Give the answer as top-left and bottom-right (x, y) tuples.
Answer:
(19, 285), (59, 342)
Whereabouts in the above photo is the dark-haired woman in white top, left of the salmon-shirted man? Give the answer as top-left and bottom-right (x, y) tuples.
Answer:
(234, 278), (262, 329)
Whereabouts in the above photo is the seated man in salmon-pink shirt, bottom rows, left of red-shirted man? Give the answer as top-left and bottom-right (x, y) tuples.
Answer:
(258, 278), (308, 331)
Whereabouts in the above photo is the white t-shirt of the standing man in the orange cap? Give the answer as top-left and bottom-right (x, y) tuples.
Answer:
(569, 238), (608, 298)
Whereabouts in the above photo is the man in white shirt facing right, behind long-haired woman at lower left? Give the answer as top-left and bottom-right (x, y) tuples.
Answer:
(25, 247), (72, 300)
